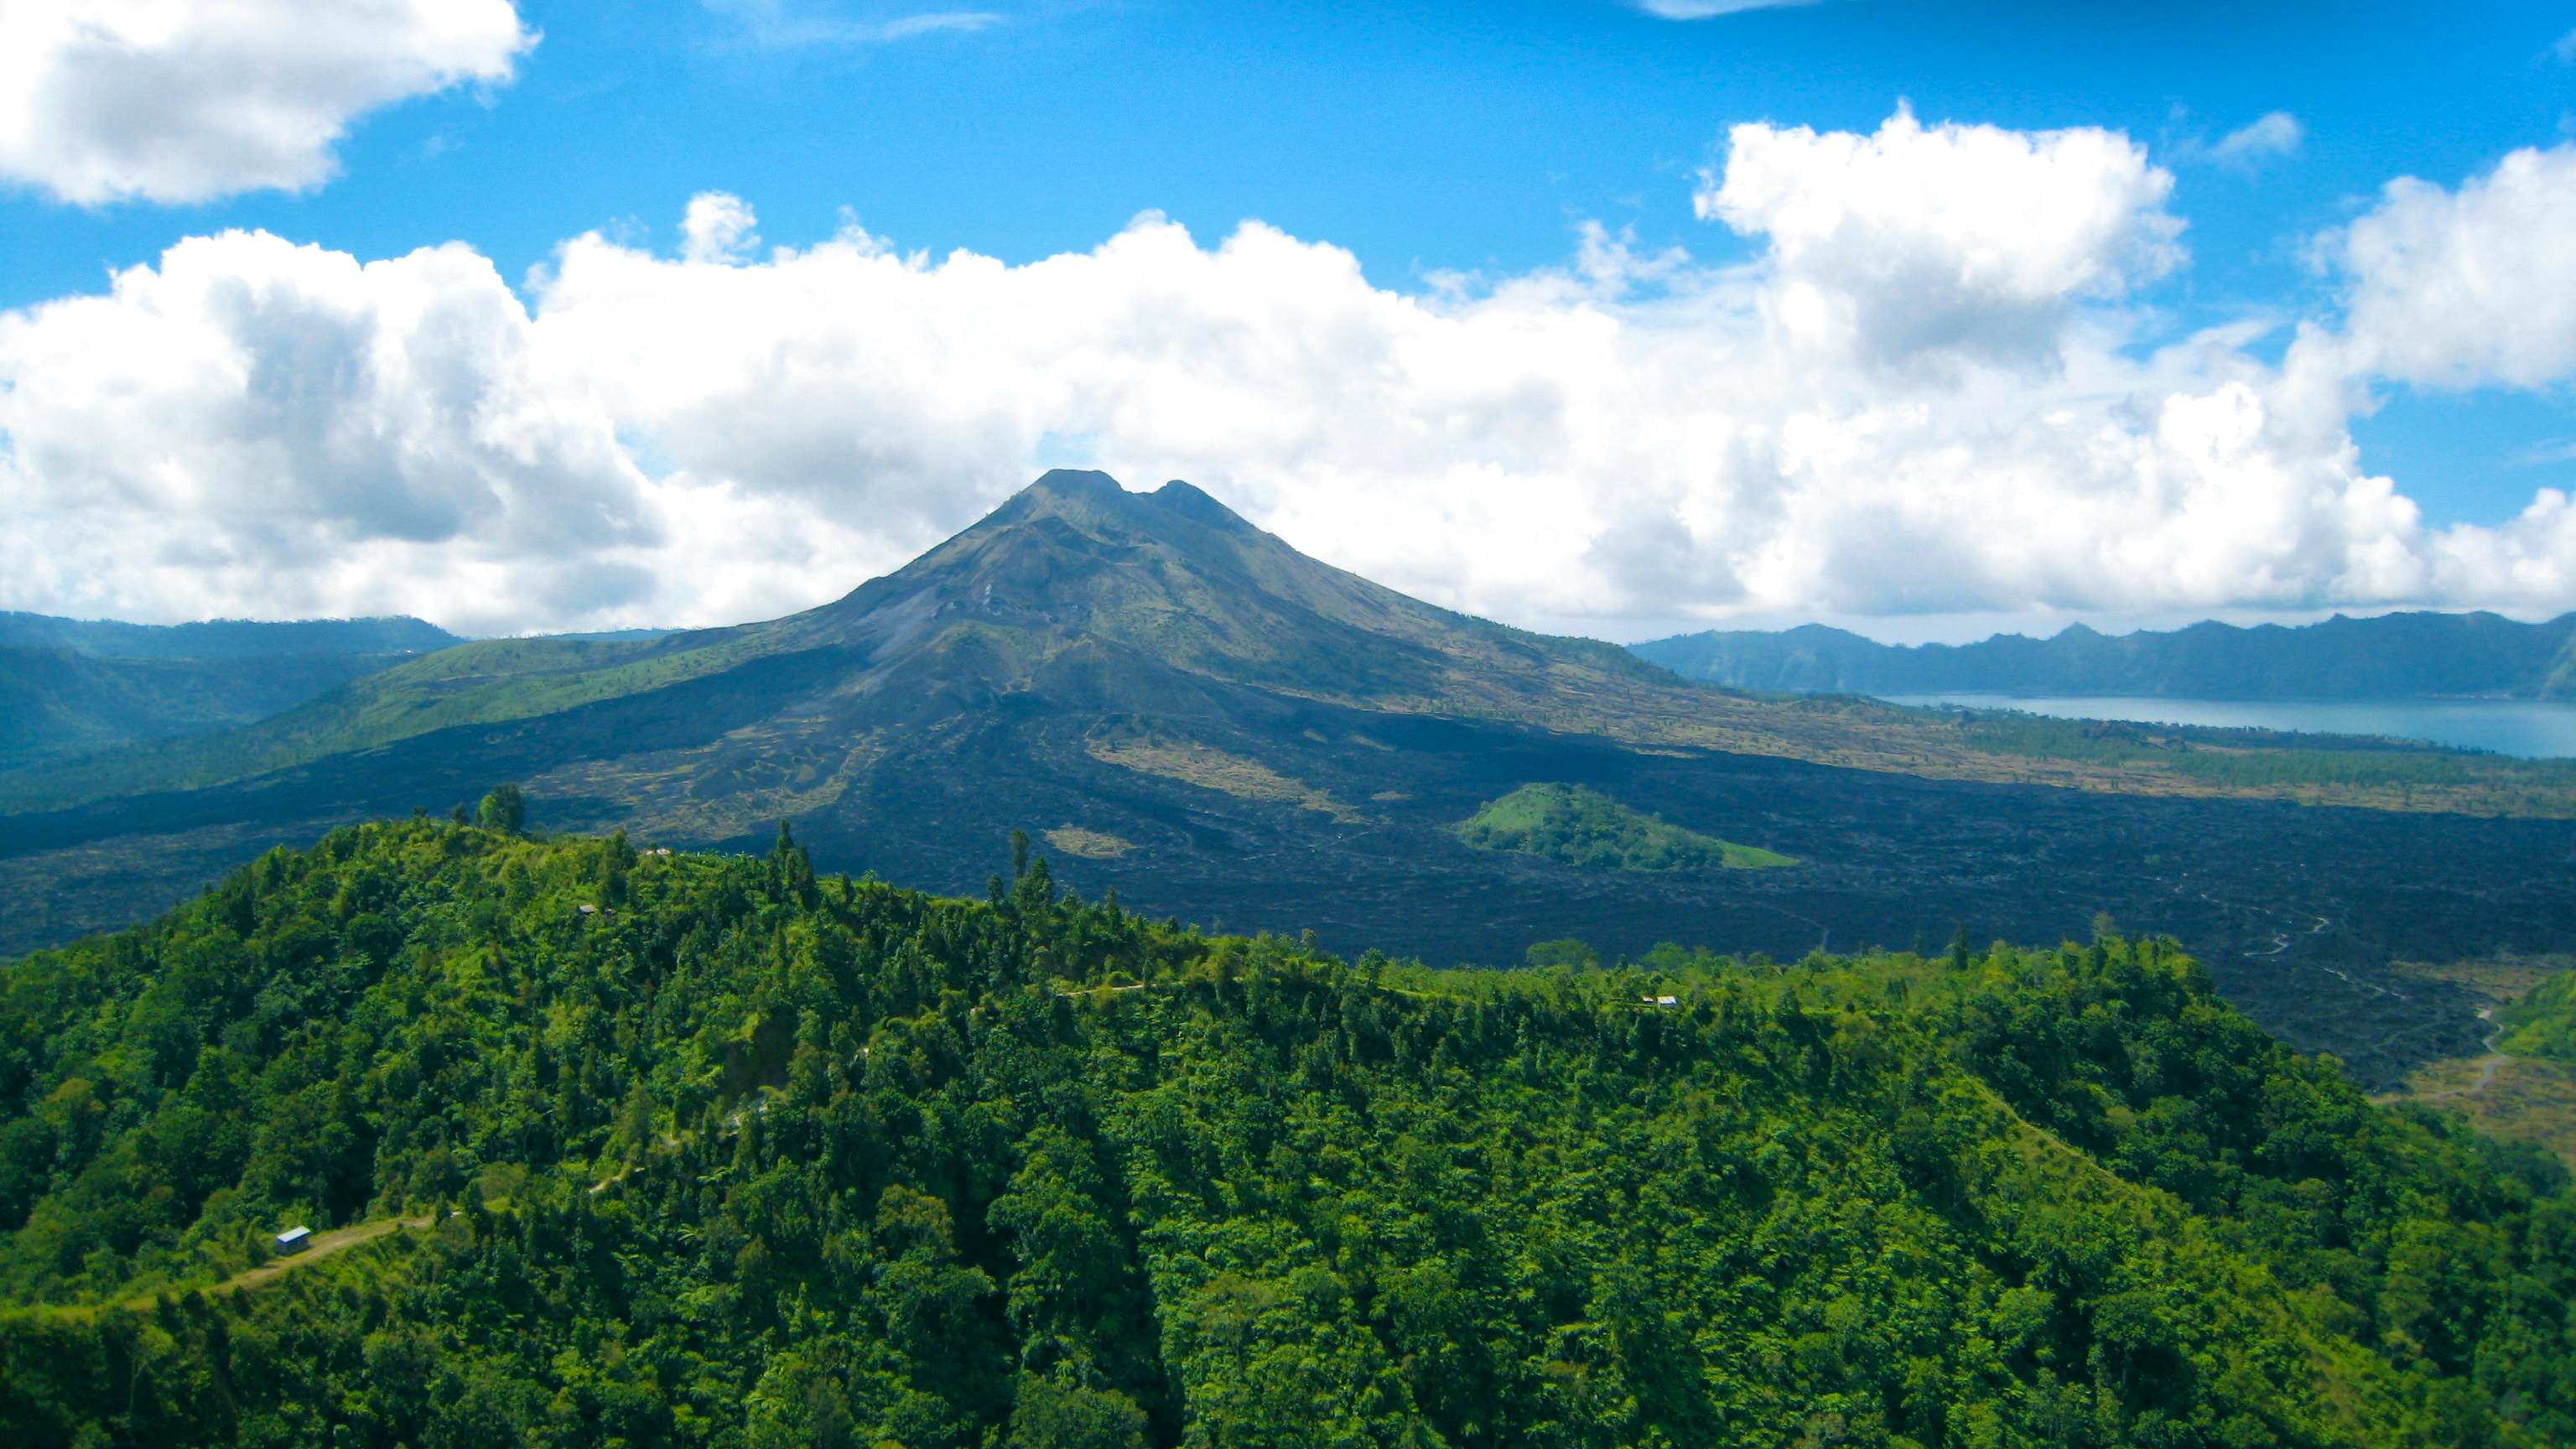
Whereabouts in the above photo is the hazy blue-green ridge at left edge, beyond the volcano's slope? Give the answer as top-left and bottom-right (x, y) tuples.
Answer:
(0, 614), (461, 771)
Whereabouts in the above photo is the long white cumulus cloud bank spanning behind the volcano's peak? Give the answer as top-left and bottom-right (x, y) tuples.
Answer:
(0, 113), (2576, 636)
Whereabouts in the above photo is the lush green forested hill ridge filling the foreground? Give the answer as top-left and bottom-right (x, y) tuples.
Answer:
(0, 823), (2576, 1449)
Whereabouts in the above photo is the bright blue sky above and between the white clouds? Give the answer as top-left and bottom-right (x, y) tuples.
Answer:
(0, 0), (2576, 634)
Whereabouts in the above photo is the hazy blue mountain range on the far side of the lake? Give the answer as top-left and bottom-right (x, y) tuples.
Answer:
(1633, 614), (2576, 699)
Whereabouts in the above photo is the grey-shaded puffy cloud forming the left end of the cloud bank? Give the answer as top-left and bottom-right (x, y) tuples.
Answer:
(0, 232), (662, 616)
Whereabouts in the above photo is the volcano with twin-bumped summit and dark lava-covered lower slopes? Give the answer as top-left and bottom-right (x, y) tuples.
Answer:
(0, 472), (2576, 1080)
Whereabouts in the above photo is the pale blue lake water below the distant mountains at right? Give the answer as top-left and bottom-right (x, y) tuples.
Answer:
(1883, 693), (2576, 761)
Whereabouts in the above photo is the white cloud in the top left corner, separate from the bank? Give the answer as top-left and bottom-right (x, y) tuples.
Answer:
(0, 0), (536, 204)
